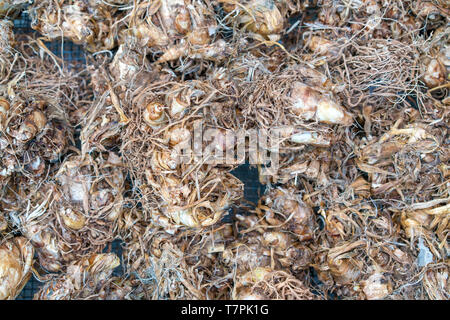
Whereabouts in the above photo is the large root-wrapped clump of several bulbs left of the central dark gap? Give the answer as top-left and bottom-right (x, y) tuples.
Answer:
(116, 81), (243, 232)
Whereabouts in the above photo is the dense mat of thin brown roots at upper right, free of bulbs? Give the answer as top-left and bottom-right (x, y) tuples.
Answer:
(340, 39), (424, 106)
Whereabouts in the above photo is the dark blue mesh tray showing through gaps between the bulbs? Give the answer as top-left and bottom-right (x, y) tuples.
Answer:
(14, 12), (264, 300)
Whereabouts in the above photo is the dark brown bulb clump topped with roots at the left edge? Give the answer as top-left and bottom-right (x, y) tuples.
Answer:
(0, 38), (89, 188)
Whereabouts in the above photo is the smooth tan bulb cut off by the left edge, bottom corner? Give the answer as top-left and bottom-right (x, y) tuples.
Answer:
(0, 237), (34, 300)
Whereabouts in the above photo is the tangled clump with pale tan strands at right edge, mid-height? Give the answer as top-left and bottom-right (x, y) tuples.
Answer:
(355, 118), (448, 206)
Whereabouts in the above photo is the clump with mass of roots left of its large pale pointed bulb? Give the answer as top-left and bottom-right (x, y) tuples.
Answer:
(230, 56), (352, 132)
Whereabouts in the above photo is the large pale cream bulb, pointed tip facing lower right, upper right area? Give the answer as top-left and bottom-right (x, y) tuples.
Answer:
(291, 82), (353, 126)
